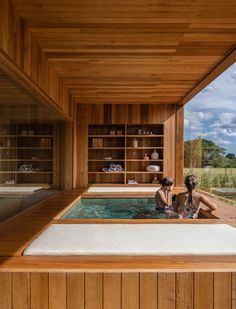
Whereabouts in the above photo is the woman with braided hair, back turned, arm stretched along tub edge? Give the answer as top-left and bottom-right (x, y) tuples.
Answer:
(174, 175), (217, 219)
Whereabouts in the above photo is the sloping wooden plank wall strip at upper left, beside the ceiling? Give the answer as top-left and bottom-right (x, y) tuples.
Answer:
(0, 0), (71, 115)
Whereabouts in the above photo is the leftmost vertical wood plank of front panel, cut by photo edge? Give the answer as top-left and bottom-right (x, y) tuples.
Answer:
(0, 273), (12, 309)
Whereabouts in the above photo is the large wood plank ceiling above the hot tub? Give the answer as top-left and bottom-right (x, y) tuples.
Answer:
(12, 0), (236, 104)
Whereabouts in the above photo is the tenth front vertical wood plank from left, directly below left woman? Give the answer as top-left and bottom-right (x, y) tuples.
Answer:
(158, 273), (175, 309)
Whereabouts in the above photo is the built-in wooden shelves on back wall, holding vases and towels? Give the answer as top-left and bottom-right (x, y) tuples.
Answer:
(88, 124), (164, 184)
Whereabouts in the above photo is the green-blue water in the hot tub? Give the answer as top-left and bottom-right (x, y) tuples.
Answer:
(62, 198), (206, 219)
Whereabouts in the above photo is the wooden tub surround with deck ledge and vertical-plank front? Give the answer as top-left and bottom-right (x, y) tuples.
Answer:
(0, 190), (236, 309)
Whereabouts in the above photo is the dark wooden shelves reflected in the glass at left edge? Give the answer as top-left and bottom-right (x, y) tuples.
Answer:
(0, 124), (53, 184)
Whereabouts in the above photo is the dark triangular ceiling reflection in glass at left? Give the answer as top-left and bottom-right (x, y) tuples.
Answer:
(0, 71), (59, 124)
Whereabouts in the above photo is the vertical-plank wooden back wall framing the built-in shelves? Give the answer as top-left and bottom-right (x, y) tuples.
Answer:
(73, 104), (183, 188)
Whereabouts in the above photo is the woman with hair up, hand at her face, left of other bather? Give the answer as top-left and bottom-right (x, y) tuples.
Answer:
(155, 177), (178, 218)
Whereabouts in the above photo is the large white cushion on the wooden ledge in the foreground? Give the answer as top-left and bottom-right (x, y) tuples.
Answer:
(24, 224), (236, 255)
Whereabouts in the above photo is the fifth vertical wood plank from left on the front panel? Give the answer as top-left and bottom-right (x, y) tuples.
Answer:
(66, 273), (84, 309)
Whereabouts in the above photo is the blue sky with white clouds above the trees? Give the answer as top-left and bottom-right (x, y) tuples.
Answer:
(184, 63), (236, 155)
